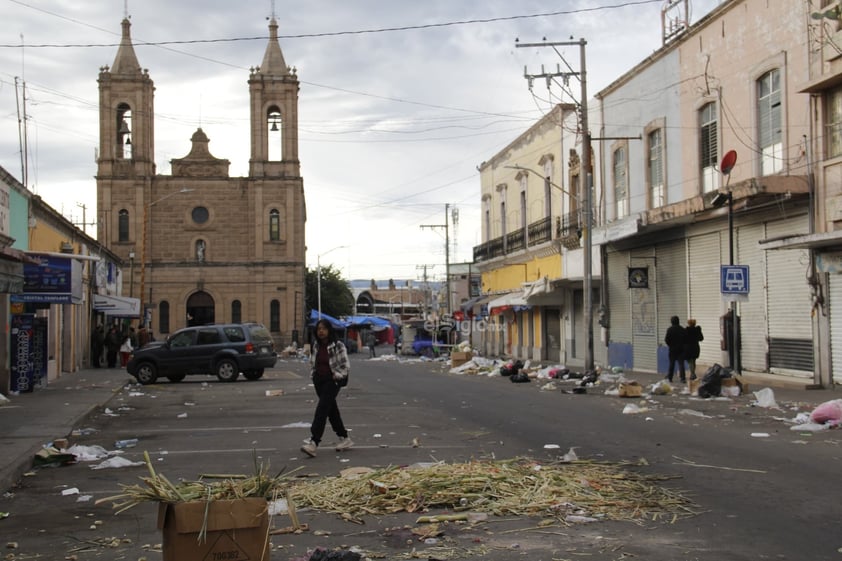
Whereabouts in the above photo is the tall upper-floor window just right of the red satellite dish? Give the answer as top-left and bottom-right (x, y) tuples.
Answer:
(757, 69), (783, 175)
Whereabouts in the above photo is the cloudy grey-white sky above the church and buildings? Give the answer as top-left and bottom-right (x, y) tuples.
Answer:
(0, 0), (720, 279)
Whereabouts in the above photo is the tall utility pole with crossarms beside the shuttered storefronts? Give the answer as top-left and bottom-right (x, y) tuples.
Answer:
(515, 39), (594, 371)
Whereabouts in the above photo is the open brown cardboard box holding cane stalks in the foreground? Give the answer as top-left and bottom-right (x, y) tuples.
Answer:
(158, 498), (270, 561)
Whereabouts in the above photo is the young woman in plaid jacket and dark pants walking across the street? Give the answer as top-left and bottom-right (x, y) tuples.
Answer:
(301, 319), (354, 458)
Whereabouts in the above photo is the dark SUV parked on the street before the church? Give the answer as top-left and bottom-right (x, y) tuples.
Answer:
(126, 323), (278, 384)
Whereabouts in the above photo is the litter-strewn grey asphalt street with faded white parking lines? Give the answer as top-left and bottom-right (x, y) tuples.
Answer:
(0, 355), (842, 561)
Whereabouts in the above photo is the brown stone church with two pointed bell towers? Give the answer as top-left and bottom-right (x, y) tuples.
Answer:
(96, 18), (306, 346)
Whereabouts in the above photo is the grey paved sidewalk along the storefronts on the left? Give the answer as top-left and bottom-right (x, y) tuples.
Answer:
(0, 368), (134, 492)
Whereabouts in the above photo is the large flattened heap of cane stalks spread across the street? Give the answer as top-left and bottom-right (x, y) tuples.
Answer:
(290, 458), (697, 523)
